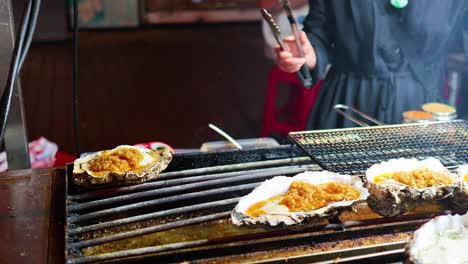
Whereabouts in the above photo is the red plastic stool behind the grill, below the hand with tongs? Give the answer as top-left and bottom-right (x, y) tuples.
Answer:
(261, 65), (322, 137)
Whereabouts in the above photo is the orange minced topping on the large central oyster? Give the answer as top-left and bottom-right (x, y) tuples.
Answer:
(246, 181), (360, 217)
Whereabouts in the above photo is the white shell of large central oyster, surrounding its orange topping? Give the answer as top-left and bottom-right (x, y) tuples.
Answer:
(231, 171), (368, 226)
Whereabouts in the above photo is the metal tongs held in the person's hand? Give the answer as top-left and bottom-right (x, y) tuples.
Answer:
(261, 0), (312, 88)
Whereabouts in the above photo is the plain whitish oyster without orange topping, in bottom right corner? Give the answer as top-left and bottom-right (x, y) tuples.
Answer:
(405, 214), (468, 264)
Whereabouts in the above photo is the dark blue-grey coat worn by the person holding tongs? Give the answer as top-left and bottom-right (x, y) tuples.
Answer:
(304, 0), (468, 129)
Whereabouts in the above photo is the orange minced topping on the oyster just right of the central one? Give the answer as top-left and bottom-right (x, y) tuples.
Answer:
(374, 168), (454, 188)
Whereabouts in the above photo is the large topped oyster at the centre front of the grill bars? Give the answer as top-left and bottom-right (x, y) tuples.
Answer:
(231, 171), (368, 226)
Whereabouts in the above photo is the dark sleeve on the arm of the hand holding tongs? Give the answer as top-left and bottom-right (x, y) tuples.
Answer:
(303, 0), (331, 83)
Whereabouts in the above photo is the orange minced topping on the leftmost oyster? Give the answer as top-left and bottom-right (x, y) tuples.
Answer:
(89, 148), (144, 172)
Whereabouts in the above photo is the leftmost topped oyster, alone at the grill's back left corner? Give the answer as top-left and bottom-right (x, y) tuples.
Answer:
(73, 146), (172, 186)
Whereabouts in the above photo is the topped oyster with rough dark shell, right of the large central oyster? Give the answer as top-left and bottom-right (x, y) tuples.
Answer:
(365, 158), (456, 217)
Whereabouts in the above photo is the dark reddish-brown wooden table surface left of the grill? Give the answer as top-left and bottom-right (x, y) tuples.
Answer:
(0, 168), (65, 263)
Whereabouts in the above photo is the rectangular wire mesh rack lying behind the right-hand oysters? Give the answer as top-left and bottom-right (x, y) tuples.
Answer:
(289, 120), (468, 174)
